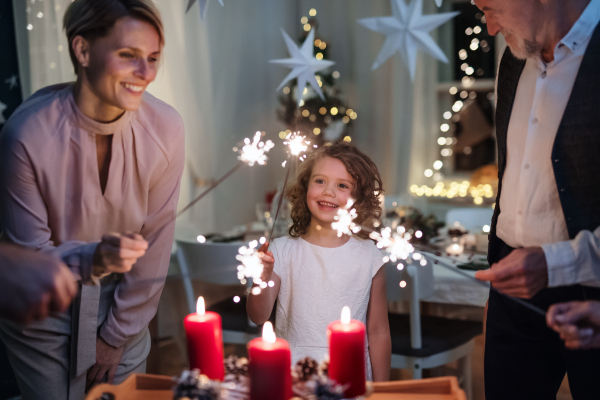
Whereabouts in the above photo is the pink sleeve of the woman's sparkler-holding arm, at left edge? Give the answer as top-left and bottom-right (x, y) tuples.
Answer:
(0, 130), (98, 284)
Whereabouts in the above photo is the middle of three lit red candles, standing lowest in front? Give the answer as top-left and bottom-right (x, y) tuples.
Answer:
(248, 321), (292, 400)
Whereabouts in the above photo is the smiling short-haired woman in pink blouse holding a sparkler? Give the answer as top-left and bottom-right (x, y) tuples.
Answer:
(0, 0), (184, 399)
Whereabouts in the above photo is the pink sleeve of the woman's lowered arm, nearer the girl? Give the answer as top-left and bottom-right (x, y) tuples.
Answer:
(100, 116), (185, 347)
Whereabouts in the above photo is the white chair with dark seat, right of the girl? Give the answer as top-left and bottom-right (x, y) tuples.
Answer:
(385, 261), (483, 399)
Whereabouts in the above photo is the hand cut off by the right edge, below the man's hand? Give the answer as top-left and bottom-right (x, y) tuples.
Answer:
(546, 301), (600, 349)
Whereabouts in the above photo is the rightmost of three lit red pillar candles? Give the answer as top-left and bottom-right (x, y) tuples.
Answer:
(327, 307), (366, 398)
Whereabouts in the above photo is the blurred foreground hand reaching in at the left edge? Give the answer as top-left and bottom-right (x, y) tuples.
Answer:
(0, 245), (77, 324)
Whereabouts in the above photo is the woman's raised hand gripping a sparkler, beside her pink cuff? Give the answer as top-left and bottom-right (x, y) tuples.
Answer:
(94, 233), (148, 276)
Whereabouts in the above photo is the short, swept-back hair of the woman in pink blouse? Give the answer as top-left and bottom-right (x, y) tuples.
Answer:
(63, 0), (165, 74)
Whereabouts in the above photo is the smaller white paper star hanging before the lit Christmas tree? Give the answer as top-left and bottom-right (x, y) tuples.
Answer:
(269, 29), (335, 107)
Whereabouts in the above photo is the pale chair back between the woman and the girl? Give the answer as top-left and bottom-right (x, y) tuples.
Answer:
(176, 239), (246, 285)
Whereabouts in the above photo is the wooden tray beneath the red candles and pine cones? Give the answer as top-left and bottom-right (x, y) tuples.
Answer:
(86, 374), (467, 400)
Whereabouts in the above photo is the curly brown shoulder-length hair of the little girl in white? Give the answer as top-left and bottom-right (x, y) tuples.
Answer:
(286, 141), (383, 239)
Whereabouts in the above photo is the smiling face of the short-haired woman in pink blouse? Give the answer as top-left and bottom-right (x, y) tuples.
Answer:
(85, 17), (160, 111)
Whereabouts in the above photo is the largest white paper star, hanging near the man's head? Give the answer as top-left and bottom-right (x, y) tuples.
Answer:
(358, 0), (460, 81)
